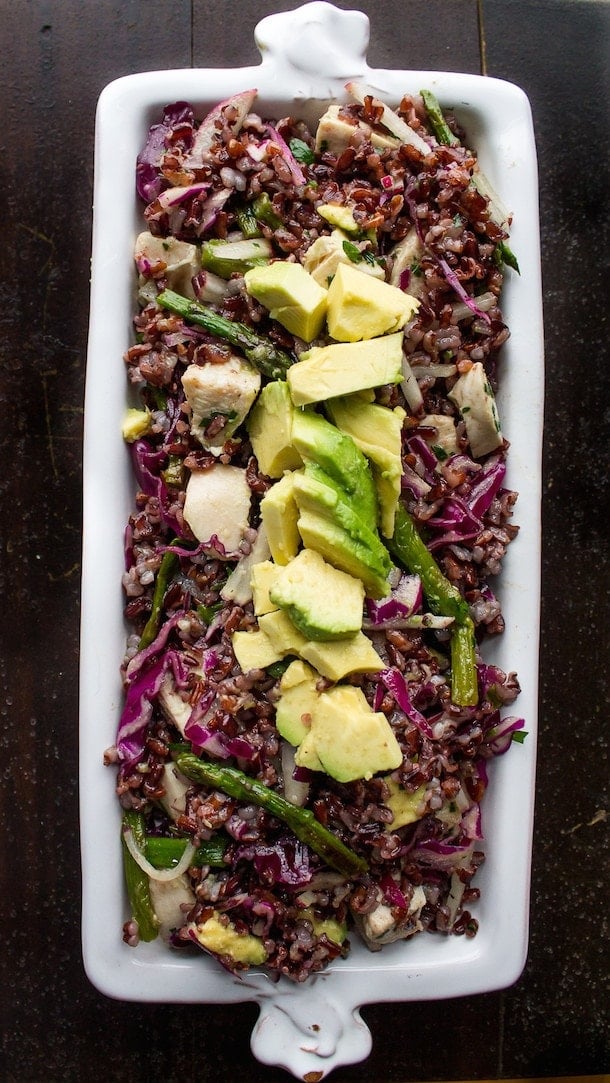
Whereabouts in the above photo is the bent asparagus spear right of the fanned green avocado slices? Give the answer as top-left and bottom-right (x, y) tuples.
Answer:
(388, 504), (479, 707)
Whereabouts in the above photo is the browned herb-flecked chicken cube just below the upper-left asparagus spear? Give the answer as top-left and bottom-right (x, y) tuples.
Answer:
(182, 354), (260, 455)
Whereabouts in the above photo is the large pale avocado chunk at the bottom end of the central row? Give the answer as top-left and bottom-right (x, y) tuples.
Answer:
(296, 684), (402, 782)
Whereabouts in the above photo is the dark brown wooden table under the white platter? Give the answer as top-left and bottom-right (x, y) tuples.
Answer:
(0, 0), (610, 1083)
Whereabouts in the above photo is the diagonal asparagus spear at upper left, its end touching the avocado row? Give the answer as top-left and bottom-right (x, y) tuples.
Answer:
(157, 289), (293, 380)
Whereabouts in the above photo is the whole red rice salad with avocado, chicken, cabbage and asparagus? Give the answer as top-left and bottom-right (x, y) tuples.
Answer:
(105, 82), (524, 982)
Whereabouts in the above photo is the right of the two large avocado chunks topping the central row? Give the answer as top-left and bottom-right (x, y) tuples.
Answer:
(327, 263), (419, 342)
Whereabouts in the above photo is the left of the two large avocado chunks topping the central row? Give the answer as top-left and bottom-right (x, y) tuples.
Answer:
(244, 260), (326, 342)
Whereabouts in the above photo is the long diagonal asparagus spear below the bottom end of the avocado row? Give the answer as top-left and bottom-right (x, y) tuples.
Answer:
(176, 753), (367, 877)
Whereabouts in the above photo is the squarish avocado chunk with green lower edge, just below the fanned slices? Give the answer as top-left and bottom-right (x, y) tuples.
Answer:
(269, 549), (364, 640)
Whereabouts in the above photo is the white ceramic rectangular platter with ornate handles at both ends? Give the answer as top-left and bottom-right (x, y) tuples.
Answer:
(80, 2), (543, 1079)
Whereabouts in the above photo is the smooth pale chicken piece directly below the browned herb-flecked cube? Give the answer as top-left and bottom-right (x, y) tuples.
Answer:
(184, 462), (251, 556)
